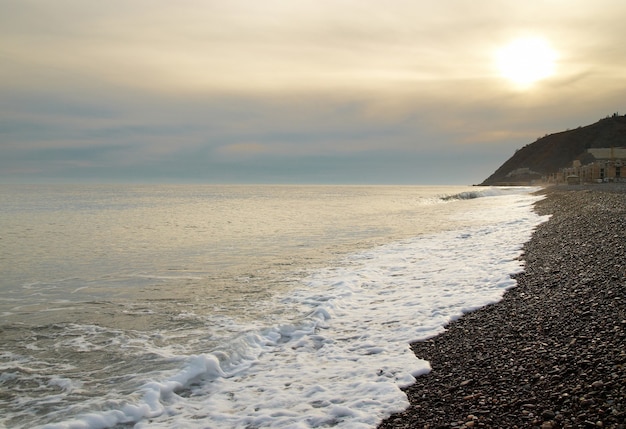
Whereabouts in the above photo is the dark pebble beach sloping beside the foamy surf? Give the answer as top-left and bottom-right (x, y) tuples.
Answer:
(379, 184), (626, 429)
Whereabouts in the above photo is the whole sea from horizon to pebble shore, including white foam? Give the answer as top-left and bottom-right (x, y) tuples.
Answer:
(0, 185), (545, 428)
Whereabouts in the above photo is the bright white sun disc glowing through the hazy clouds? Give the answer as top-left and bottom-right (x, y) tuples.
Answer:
(496, 37), (557, 88)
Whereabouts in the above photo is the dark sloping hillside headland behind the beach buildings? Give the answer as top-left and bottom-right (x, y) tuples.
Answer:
(481, 114), (626, 185)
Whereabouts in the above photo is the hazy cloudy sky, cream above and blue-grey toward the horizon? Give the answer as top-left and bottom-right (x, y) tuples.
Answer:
(0, 0), (626, 185)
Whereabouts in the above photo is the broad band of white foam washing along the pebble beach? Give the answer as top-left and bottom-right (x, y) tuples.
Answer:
(34, 192), (545, 429)
